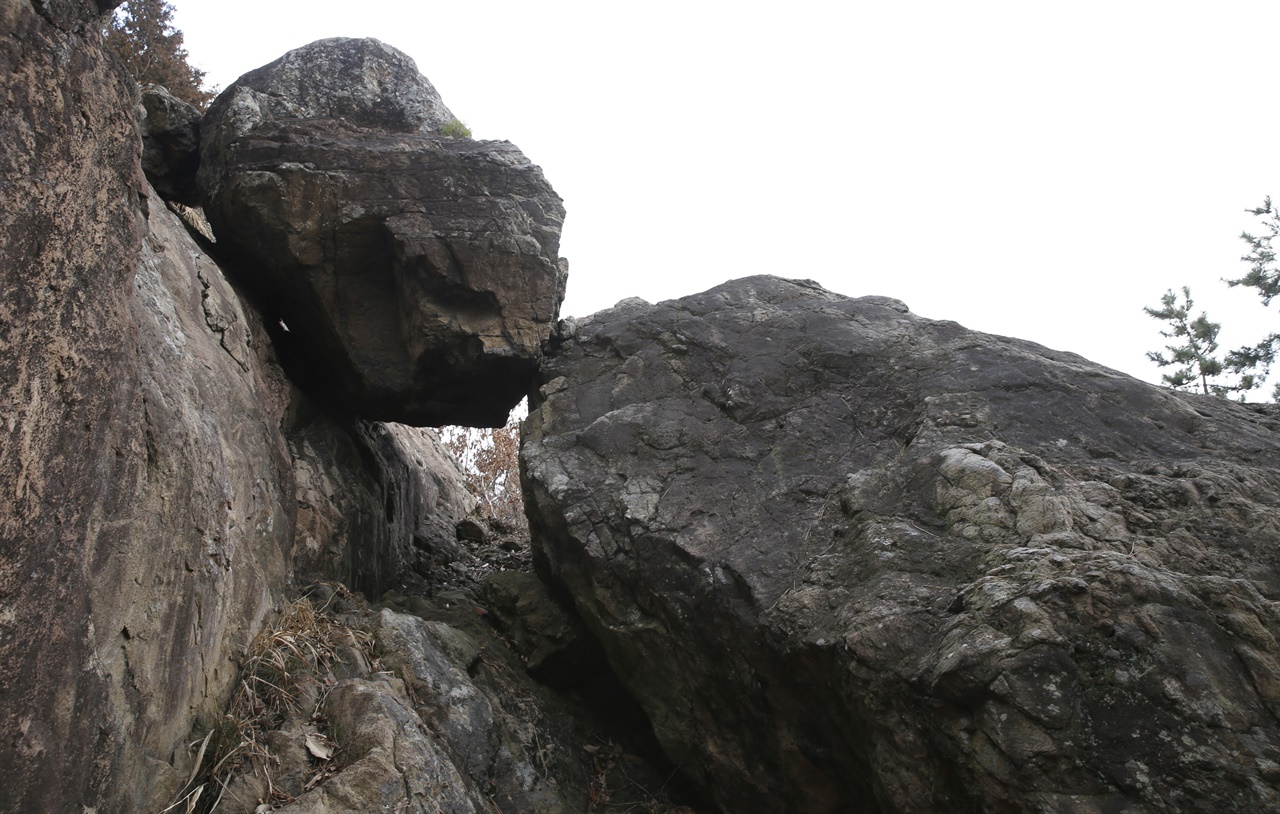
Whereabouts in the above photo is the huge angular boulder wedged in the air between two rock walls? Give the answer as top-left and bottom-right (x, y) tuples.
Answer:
(200, 40), (566, 426)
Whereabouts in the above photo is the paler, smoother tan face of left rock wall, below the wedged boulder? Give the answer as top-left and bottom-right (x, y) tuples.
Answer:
(104, 188), (293, 808)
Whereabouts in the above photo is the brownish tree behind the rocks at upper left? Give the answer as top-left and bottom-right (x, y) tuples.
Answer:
(104, 0), (215, 109)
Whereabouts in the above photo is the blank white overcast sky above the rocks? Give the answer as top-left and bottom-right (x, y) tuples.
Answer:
(172, 0), (1280, 399)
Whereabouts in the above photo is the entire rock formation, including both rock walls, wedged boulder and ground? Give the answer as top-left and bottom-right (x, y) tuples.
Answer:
(0, 0), (1280, 814)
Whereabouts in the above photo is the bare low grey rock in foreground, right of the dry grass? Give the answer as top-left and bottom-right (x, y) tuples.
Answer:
(206, 585), (694, 814)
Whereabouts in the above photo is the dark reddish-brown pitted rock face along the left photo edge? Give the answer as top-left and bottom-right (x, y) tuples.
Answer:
(0, 0), (175, 811)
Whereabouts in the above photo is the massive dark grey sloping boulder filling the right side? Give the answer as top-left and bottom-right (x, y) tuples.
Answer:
(522, 278), (1280, 814)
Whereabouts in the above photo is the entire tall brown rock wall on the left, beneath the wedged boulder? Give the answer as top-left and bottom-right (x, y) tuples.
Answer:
(0, 9), (481, 813)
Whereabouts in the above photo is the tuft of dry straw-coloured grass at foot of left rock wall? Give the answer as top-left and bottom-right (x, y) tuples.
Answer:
(163, 586), (372, 814)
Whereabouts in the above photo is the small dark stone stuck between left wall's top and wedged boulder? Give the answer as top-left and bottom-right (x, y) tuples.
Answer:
(138, 84), (201, 206)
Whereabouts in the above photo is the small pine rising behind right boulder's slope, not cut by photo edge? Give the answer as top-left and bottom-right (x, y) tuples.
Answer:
(1143, 285), (1261, 399)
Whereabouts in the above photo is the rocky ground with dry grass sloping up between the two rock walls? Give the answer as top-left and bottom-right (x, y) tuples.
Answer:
(168, 509), (710, 814)
